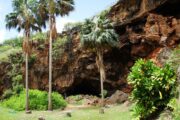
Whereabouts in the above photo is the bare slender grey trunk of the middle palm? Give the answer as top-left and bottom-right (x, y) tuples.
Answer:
(48, 15), (53, 111)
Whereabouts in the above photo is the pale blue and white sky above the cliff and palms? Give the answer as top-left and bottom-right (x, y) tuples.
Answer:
(0, 0), (118, 43)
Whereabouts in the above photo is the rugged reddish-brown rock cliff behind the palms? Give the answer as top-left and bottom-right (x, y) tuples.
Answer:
(0, 0), (180, 95)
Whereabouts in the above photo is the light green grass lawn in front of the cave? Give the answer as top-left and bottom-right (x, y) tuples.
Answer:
(0, 105), (131, 120)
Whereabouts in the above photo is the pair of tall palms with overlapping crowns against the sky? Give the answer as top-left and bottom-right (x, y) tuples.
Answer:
(6, 0), (74, 113)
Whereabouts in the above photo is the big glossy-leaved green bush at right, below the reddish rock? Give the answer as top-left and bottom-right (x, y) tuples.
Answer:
(128, 59), (176, 119)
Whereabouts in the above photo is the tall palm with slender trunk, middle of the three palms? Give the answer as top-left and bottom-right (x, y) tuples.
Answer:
(39, 0), (74, 110)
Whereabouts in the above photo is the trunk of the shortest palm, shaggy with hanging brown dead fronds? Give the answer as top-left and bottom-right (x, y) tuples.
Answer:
(96, 49), (106, 112)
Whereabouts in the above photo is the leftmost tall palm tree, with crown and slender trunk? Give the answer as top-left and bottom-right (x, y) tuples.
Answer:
(6, 0), (45, 113)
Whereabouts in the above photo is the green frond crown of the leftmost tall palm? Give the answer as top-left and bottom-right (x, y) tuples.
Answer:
(5, 0), (45, 32)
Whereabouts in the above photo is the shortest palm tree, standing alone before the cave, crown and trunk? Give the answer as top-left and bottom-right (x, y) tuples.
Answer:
(81, 16), (118, 113)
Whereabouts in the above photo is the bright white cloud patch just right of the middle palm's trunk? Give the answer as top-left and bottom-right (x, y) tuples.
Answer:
(56, 17), (76, 33)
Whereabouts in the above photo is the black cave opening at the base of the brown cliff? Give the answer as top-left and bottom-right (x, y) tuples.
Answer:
(67, 80), (100, 97)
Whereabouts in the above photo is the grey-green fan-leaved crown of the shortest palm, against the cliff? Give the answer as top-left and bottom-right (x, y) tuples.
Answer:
(81, 16), (119, 49)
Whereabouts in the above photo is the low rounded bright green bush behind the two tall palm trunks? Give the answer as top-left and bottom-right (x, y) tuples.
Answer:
(1, 90), (67, 111)
